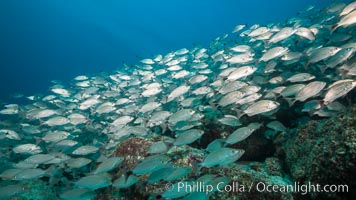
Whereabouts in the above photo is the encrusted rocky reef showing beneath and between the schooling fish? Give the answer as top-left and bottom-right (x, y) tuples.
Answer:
(92, 106), (356, 200)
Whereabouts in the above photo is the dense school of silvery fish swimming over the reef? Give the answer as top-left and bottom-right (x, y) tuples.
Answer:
(0, 2), (356, 199)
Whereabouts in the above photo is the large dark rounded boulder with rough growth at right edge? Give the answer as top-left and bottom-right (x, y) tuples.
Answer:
(277, 106), (356, 199)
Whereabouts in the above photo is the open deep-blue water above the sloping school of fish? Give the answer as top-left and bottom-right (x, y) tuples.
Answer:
(0, 0), (340, 101)
